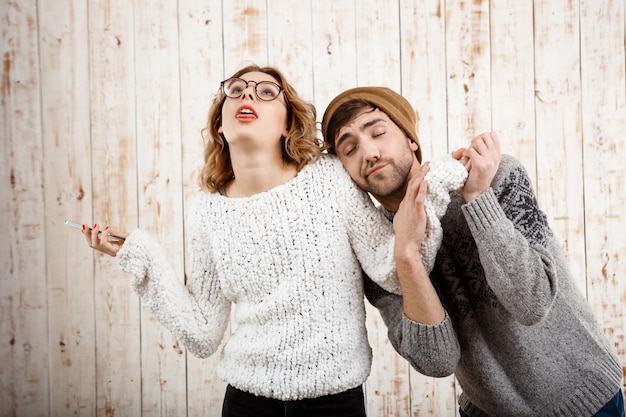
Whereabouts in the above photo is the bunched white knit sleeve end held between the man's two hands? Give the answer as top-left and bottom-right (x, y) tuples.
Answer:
(420, 155), (467, 272)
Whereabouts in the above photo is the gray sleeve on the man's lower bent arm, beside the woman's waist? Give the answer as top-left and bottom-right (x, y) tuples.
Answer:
(364, 277), (461, 377)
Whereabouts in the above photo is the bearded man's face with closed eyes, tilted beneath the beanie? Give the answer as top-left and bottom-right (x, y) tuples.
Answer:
(335, 108), (418, 205)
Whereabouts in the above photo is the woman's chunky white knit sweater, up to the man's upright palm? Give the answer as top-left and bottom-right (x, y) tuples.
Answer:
(117, 155), (400, 400)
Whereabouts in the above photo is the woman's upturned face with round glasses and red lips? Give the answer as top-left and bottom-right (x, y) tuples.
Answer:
(219, 72), (288, 150)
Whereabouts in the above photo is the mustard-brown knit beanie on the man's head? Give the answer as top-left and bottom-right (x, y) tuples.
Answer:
(322, 87), (422, 162)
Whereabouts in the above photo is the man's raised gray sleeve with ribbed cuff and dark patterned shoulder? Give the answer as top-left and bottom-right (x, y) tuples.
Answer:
(462, 156), (558, 325)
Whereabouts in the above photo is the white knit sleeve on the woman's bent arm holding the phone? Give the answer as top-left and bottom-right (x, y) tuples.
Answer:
(117, 198), (230, 358)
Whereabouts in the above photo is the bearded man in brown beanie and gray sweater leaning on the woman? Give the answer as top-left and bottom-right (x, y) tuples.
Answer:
(322, 87), (624, 417)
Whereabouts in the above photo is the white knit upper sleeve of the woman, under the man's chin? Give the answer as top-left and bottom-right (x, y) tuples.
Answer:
(334, 160), (401, 294)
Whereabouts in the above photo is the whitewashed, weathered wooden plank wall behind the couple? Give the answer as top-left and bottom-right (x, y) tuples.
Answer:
(0, 0), (626, 417)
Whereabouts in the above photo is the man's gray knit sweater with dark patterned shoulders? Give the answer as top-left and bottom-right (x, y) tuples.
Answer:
(366, 155), (622, 417)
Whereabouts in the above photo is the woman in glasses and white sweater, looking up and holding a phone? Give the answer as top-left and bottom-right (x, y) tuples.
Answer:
(83, 66), (400, 416)
